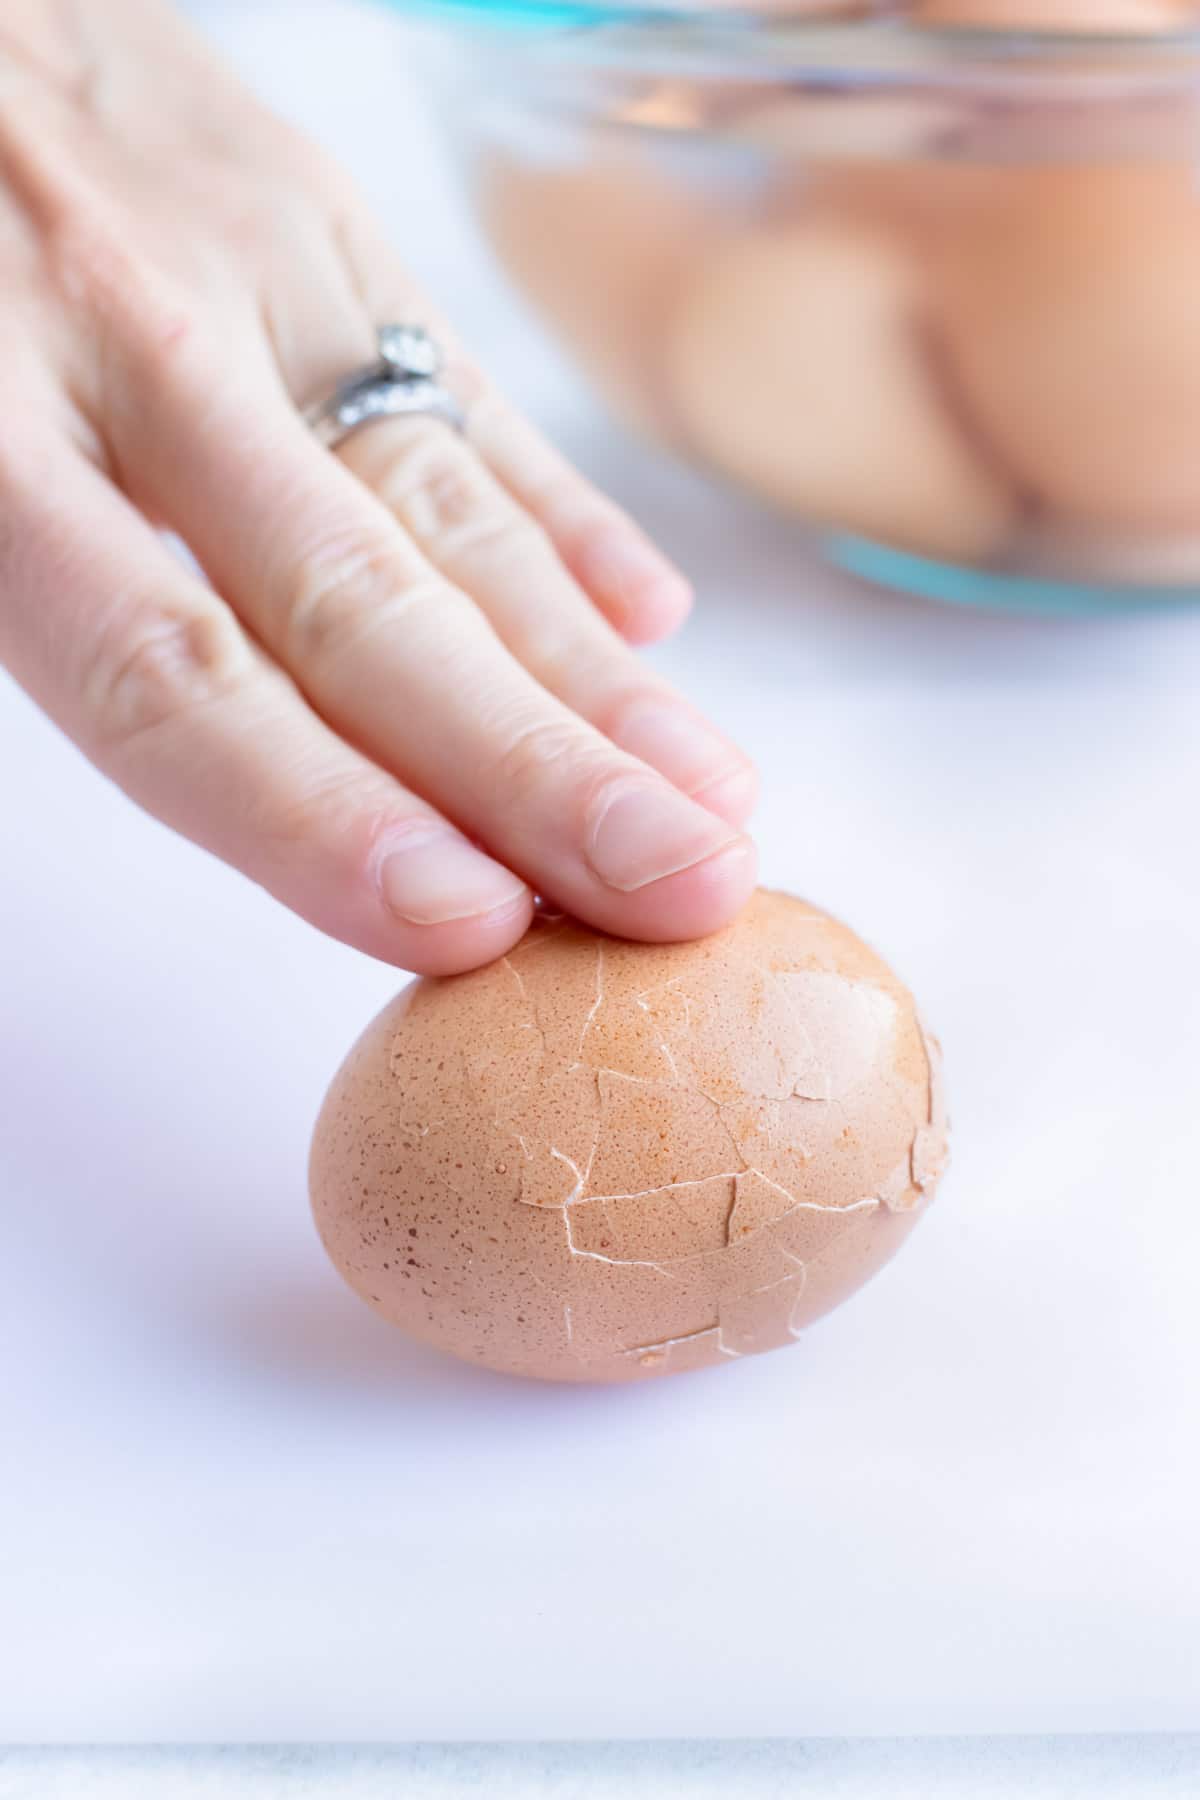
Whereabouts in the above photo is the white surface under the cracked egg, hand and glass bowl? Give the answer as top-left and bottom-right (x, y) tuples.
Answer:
(0, 5), (1200, 1741)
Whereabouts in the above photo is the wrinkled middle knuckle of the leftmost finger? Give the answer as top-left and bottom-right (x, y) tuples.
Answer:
(85, 603), (254, 752)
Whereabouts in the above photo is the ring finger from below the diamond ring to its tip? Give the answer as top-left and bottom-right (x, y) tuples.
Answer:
(332, 419), (756, 826)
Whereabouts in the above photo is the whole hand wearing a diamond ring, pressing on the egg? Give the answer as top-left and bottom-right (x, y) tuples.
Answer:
(0, 0), (754, 972)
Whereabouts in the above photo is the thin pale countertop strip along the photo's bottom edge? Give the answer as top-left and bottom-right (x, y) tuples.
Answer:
(0, 1735), (1200, 1800)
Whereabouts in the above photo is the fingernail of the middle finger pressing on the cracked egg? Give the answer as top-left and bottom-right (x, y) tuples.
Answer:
(585, 778), (738, 893)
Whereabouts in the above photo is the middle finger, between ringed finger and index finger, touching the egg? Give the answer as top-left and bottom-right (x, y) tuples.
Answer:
(110, 346), (754, 940)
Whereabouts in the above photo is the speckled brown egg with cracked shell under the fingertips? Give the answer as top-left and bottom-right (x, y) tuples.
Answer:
(311, 893), (946, 1381)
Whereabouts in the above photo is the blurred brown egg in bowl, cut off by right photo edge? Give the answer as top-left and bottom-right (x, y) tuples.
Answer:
(941, 164), (1200, 531)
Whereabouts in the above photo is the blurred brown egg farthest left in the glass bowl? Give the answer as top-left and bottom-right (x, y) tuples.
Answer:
(479, 151), (718, 436)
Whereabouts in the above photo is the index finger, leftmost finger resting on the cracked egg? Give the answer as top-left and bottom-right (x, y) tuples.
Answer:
(0, 452), (533, 974)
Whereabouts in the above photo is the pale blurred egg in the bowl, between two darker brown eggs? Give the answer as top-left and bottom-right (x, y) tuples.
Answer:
(666, 216), (1015, 562)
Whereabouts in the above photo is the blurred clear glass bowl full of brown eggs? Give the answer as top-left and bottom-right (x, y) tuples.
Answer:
(437, 0), (1200, 612)
